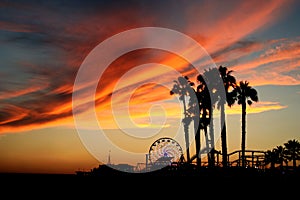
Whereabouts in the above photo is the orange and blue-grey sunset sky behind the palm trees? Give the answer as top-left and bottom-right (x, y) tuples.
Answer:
(0, 0), (300, 173)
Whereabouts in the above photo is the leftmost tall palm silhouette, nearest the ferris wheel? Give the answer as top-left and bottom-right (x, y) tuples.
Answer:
(170, 76), (195, 163)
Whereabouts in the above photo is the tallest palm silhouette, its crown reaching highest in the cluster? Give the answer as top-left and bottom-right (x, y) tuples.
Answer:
(218, 66), (237, 167)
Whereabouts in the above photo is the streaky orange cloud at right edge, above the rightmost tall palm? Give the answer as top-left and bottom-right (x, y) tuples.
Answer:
(230, 38), (300, 85)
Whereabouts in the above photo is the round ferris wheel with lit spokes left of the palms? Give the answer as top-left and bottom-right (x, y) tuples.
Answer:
(149, 137), (183, 165)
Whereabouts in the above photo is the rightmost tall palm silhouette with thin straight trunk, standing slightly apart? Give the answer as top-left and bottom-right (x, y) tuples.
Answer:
(235, 81), (258, 167)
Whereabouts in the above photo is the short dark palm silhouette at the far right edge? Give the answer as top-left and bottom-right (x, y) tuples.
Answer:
(284, 139), (300, 169)
